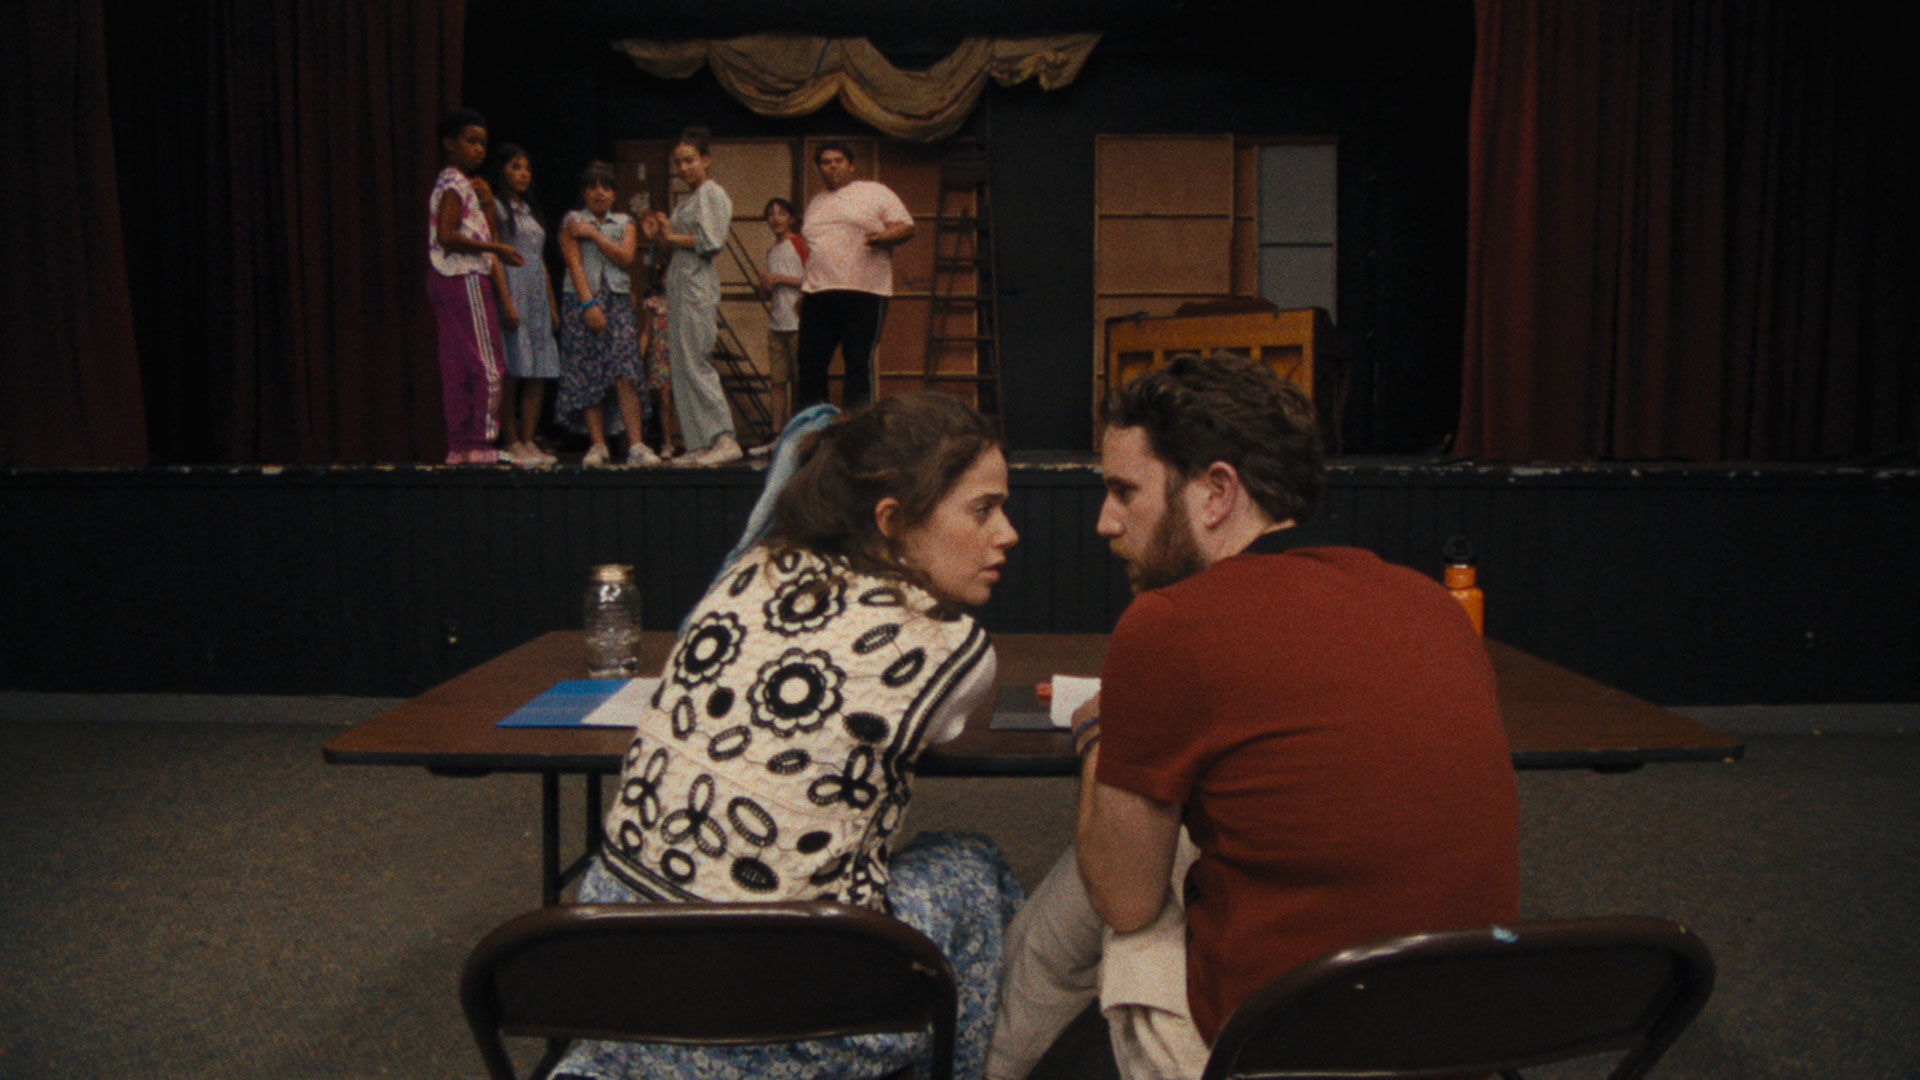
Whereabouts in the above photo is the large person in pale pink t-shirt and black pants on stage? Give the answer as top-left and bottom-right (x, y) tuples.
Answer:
(793, 140), (914, 411)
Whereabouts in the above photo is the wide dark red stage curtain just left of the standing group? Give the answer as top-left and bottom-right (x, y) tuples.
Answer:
(108, 0), (465, 461)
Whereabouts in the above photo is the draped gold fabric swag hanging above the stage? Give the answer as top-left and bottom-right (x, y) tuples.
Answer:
(612, 35), (1100, 142)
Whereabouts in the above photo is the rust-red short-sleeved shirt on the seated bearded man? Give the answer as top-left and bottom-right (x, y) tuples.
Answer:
(1098, 528), (1519, 1043)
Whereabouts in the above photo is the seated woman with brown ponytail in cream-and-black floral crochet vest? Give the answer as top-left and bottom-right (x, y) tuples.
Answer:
(555, 394), (1020, 1080)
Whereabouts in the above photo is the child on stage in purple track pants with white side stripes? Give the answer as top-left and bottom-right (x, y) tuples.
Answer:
(426, 110), (522, 465)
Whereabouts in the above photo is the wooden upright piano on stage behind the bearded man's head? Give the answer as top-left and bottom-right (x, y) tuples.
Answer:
(1094, 304), (1346, 454)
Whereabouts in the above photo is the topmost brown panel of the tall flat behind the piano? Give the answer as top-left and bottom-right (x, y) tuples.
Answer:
(1094, 135), (1233, 215)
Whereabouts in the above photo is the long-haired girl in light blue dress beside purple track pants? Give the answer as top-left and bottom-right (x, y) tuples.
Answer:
(488, 142), (561, 465)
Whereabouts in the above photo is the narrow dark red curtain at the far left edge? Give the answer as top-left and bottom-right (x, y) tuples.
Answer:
(0, 0), (146, 465)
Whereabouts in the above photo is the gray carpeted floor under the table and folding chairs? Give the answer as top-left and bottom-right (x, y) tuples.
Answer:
(0, 696), (1920, 1080)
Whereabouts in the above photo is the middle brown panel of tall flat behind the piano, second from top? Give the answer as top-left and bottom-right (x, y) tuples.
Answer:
(1092, 217), (1233, 296)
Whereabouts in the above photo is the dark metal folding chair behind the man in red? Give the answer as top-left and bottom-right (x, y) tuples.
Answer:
(1202, 917), (1713, 1080)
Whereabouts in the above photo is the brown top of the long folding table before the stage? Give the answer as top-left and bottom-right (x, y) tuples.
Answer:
(324, 630), (1745, 776)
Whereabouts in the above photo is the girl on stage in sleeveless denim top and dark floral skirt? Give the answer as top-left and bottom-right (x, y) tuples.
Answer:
(559, 161), (660, 467)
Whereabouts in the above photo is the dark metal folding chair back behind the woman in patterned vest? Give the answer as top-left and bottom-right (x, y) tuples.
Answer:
(461, 901), (958, 1080)
